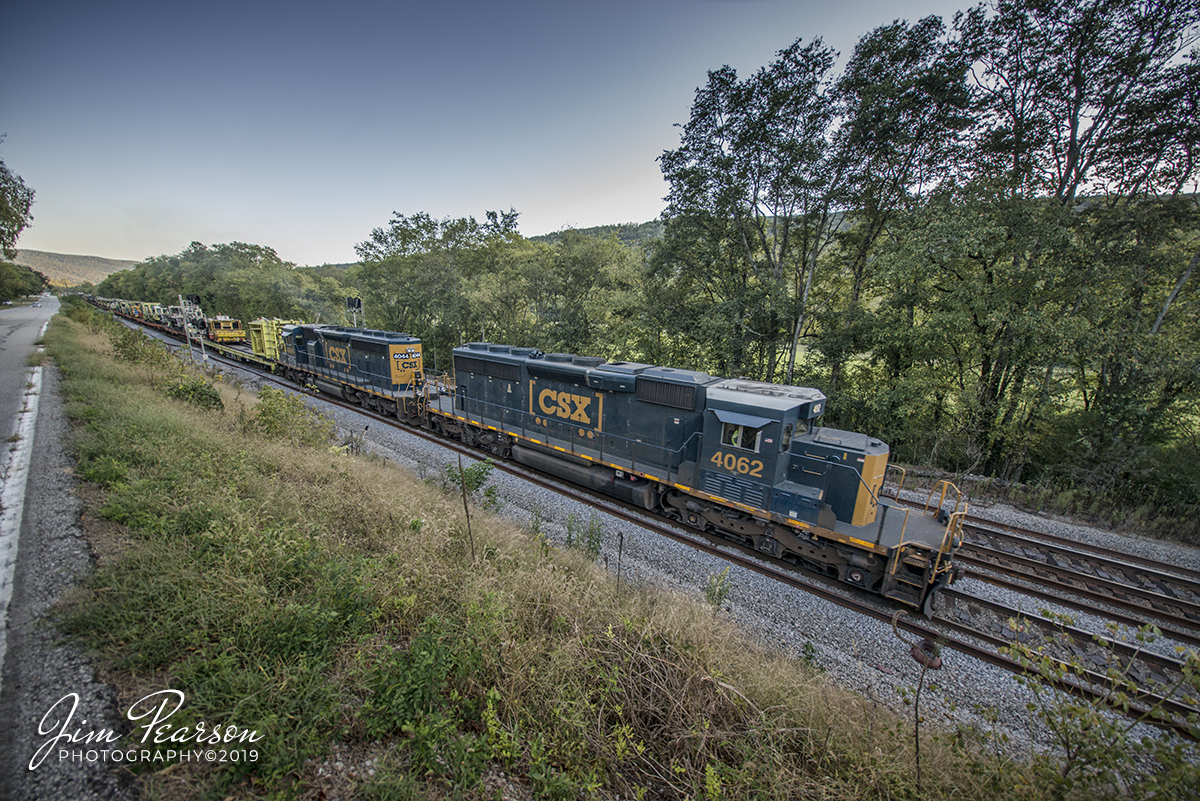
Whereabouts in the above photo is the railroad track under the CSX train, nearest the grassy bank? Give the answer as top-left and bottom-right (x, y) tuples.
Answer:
(133, 321), (1200, 739)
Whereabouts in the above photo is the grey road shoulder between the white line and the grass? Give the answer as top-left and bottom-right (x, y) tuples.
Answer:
(0, 366), (136, 801)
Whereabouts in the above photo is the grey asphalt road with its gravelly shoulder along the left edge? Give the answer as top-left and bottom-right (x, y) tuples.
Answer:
(0, 299), (133, 801)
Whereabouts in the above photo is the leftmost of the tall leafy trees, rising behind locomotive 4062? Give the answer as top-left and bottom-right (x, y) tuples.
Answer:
(658, 40), (846, 380)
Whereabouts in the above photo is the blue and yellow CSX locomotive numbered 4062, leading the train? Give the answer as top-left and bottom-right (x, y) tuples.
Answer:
(415, 343), (965, 607)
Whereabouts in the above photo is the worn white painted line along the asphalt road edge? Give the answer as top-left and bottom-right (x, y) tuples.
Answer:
(0, 367), (42, 679)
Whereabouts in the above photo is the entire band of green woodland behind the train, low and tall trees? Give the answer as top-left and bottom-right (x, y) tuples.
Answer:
(100, 1), (1200, 538)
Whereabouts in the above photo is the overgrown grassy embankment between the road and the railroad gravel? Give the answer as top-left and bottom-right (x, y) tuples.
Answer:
(37, 303), (1056, 800)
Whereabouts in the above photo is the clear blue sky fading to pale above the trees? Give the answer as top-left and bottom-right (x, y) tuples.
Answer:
(0, 0), (968, 265)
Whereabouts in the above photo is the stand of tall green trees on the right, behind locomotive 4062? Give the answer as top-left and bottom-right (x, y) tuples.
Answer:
(644, 0), (1200, 532)
